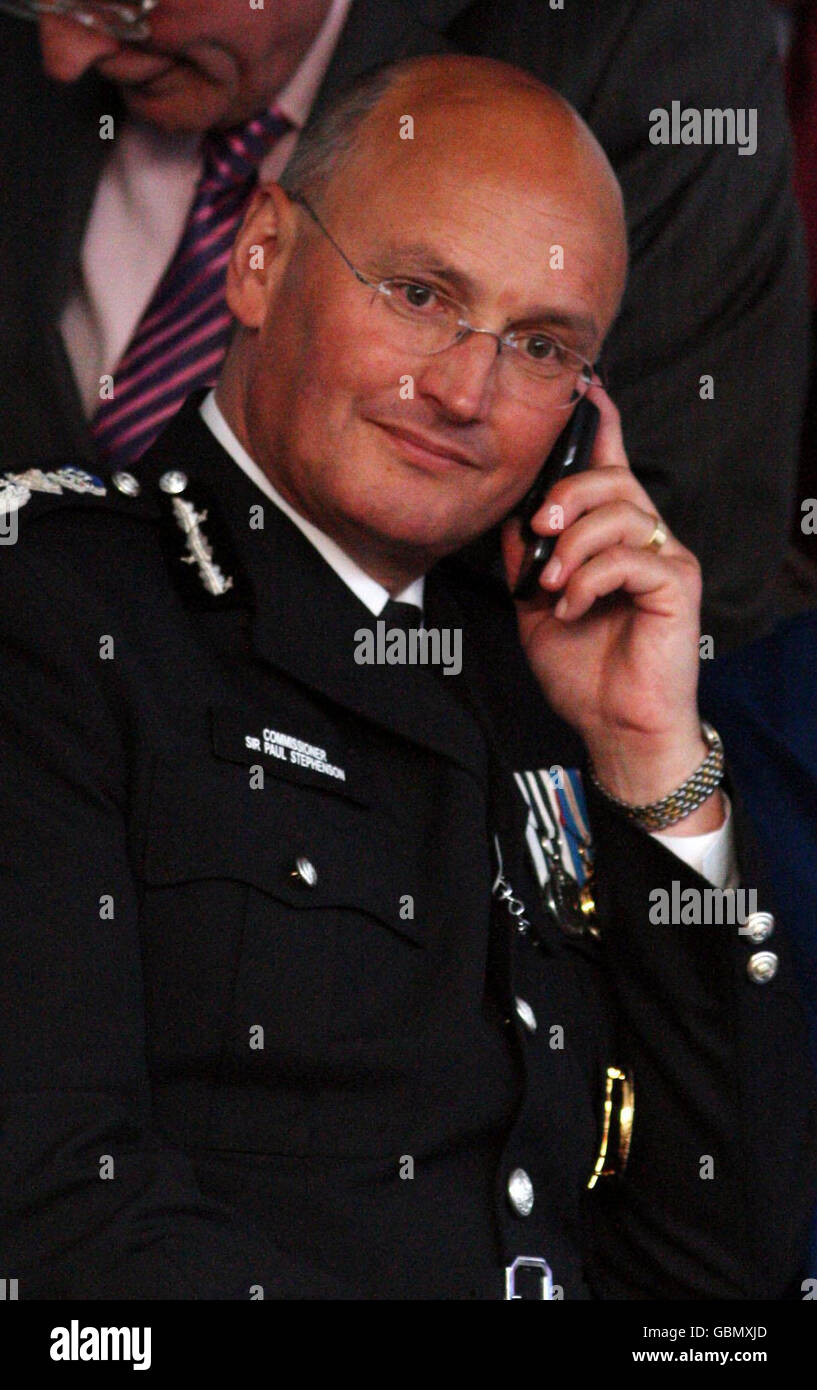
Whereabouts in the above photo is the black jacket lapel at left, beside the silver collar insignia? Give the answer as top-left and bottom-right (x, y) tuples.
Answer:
(139, 393), (485, 780)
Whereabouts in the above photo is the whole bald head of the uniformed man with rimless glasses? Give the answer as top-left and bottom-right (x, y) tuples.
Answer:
(218, 57), (627, 592)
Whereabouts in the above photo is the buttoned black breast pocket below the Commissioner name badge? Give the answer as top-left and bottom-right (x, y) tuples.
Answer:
(142, 755), (428, 1086)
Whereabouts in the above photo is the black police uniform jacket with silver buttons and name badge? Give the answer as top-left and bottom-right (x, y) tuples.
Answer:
(0, 406), (814, 1298)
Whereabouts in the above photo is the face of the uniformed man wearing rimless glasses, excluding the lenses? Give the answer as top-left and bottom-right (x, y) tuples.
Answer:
(233, 81), (622, 573)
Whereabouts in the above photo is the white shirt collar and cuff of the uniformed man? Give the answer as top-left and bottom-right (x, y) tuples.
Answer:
(200, 391), (739, 889)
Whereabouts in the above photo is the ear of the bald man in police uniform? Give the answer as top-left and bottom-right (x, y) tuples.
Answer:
(226, 183), (295, 328)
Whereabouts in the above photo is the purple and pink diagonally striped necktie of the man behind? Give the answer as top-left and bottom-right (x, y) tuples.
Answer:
(92, 108), (292, 466)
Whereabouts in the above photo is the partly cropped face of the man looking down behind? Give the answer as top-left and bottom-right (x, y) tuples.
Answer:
(39, 0), (331, 131)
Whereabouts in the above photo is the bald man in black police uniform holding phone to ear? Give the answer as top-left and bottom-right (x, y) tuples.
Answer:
(0, 58), (814, 1300)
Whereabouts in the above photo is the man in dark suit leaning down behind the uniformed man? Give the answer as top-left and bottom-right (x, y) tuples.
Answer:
(0, 0), (806, 649)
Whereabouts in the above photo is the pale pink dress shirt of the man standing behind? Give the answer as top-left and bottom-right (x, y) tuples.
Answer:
(60, 0), (352, 420)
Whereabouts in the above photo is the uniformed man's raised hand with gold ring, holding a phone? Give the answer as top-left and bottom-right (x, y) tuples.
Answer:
(503, 385), (723, 834)
